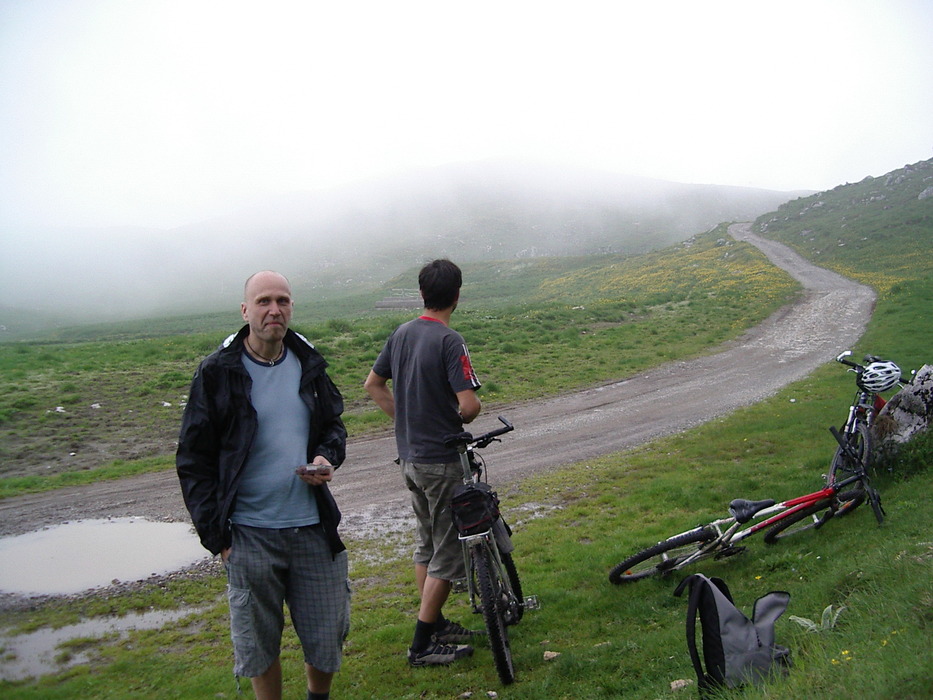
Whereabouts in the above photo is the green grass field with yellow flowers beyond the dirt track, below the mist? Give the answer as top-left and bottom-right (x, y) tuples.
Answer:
(0, 227), (796, 497)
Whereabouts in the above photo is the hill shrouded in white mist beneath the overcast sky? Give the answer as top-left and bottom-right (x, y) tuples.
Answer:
(0, 161), (806, 325)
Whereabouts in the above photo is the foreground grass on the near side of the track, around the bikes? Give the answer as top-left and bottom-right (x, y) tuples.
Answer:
(0, 316), (933, 699)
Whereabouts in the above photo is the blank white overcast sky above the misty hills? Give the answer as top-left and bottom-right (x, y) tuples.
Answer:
(0, 0), (933, 230)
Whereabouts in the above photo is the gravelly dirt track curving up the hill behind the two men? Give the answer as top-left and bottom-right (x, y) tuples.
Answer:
(0, 224), (875, 536)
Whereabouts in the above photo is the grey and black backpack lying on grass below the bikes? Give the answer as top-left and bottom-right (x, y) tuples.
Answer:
(674, 574), (790, 695)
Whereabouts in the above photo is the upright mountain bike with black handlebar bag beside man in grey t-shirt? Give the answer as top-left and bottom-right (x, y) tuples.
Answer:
(444, 416), (526, 685)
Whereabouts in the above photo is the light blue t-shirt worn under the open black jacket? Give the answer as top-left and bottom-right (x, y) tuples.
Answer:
(230, 350), (320, 529)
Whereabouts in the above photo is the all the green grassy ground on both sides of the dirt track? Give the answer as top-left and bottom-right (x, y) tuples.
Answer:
(0, 161), (933, 700)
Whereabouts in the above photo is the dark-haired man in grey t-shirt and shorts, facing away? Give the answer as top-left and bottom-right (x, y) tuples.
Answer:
(365, 260), (481, 666)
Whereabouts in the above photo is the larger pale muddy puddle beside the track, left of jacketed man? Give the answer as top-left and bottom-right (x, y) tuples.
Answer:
(0, 518), (210, 596)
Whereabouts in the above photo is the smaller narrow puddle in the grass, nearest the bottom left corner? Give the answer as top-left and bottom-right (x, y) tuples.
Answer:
(0, 608), (204, 681)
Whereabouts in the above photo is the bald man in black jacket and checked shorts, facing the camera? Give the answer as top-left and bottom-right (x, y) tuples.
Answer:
(176, 271), (350, 700)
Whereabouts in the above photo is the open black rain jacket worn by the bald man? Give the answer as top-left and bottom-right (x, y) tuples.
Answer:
(175, 326), (347, 555)
